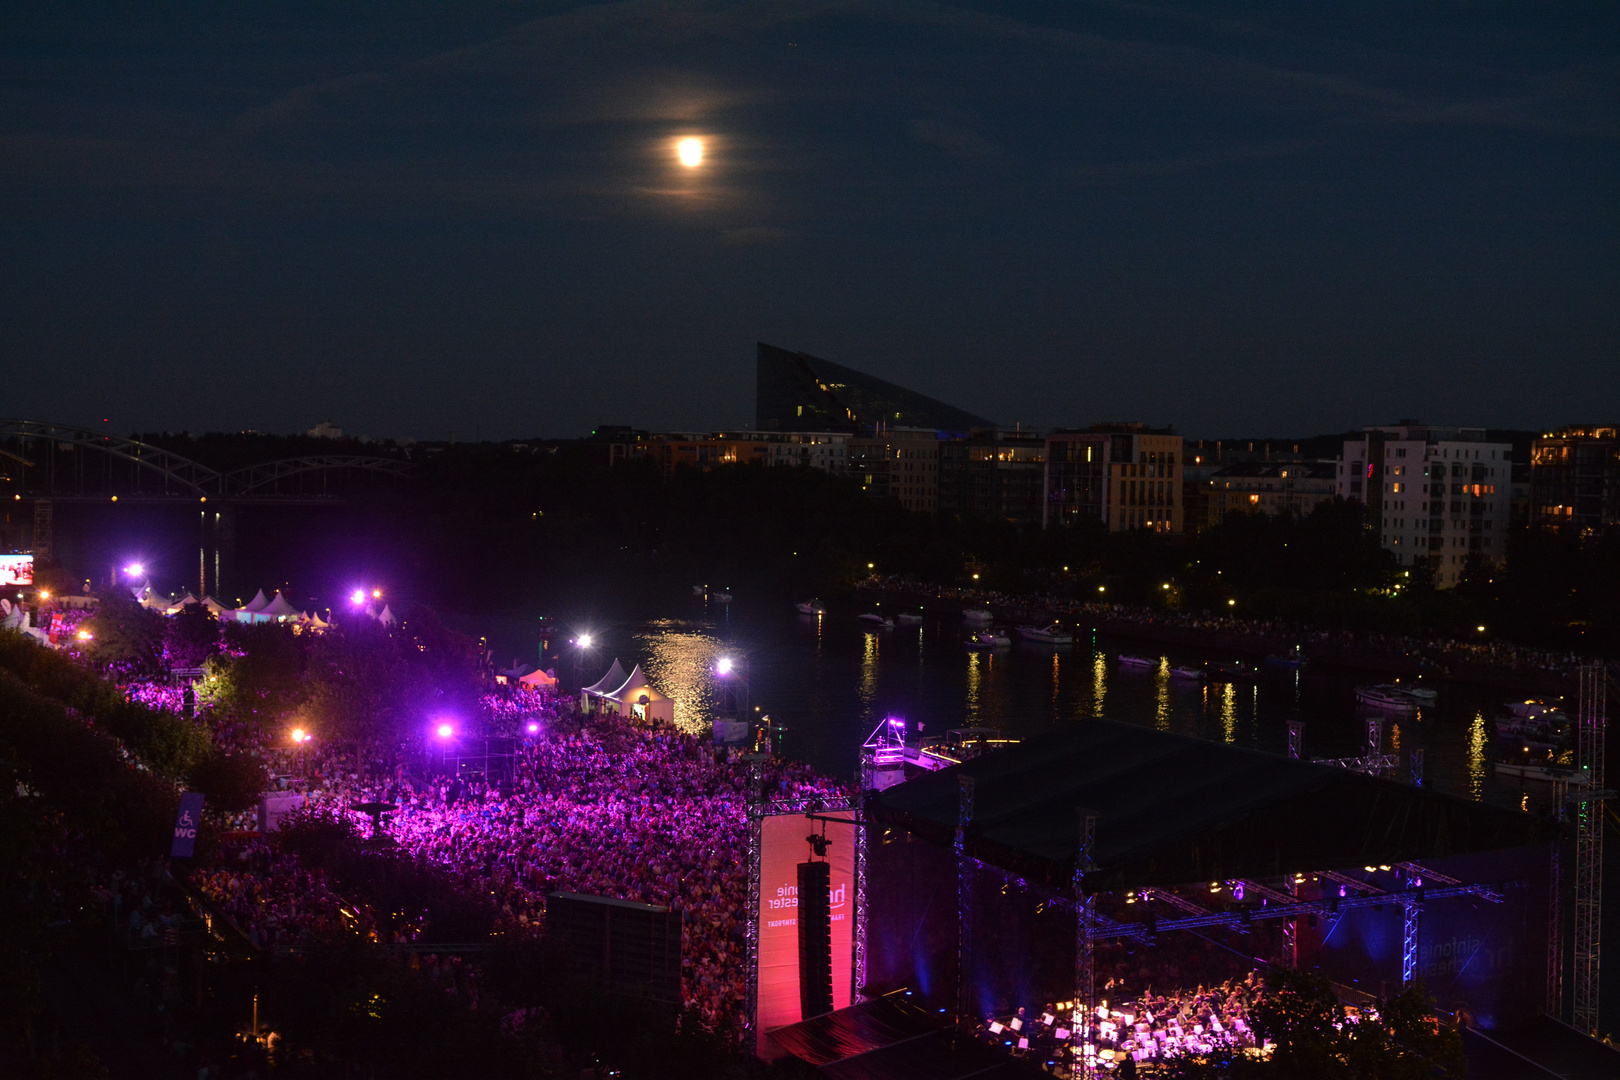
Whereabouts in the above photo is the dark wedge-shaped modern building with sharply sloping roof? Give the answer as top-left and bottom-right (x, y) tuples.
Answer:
(753, 342), (995, 434)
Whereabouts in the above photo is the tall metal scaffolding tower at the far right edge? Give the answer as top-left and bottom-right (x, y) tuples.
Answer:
(1570, 664), (1609, 1038)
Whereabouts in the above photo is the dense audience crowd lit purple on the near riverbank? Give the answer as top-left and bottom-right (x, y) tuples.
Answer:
(179, 683), (847, 1031)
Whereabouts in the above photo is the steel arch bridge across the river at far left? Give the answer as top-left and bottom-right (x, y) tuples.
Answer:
(0, 419), (413, 502)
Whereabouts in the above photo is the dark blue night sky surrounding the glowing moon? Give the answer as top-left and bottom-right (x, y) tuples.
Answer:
(0, 0), (1620, 439)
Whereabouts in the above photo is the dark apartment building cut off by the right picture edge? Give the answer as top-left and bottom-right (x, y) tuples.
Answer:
(1529, 424), (1620, 533)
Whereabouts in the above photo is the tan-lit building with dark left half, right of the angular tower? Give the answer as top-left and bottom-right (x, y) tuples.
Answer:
(1042, 424), (1186, 533)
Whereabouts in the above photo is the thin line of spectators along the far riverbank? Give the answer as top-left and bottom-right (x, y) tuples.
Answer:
(862, 576), (1620, 677)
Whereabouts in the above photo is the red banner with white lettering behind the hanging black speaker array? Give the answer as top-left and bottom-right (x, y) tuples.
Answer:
(755, 810), (855, 1059)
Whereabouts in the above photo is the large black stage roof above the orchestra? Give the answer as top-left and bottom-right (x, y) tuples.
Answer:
(872, 721), (1552, 892)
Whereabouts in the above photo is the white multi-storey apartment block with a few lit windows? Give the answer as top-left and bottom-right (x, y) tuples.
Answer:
(1337, 423), (1513, 588)
